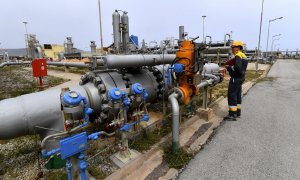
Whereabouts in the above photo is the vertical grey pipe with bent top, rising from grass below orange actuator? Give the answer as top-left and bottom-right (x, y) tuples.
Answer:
(168, 93), (180, 153)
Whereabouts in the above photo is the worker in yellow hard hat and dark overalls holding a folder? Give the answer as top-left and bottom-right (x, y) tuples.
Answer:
(224, 41), (248, 121)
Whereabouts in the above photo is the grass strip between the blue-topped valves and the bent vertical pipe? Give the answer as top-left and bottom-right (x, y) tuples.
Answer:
(129, 121), (171, 151)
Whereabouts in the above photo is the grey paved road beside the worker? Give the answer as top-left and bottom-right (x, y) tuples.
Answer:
(179, 60), (300, 180)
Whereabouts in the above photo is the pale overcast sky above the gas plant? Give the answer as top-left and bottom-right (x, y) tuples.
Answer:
(0, 0), (300, 51)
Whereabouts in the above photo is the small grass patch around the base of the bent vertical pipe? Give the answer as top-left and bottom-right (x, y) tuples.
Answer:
(163, 145), (193, 169)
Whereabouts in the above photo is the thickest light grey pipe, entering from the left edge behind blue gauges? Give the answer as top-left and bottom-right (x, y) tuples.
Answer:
(0, 86), (87, 140)
